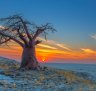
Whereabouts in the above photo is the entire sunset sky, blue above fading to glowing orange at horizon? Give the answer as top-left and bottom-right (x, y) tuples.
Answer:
(0, 0), (96, 63)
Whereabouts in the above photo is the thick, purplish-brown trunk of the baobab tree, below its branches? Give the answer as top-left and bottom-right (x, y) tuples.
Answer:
(20, 46), (40, 69)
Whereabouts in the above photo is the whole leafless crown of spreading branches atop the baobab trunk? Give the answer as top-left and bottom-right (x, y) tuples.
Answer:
(0, 15), (56, 47)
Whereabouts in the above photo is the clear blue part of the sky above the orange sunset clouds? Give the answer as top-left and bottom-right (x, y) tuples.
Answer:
(0, 0), (96, 50)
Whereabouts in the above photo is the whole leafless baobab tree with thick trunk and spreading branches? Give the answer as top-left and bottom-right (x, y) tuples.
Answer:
(0, 15), (55, 69)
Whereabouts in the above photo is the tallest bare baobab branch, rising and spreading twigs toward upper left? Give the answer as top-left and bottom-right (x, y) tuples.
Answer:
(0, 15), (32, 40)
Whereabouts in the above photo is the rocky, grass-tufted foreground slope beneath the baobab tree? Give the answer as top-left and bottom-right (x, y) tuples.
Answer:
(0, 58), (96, 91)
